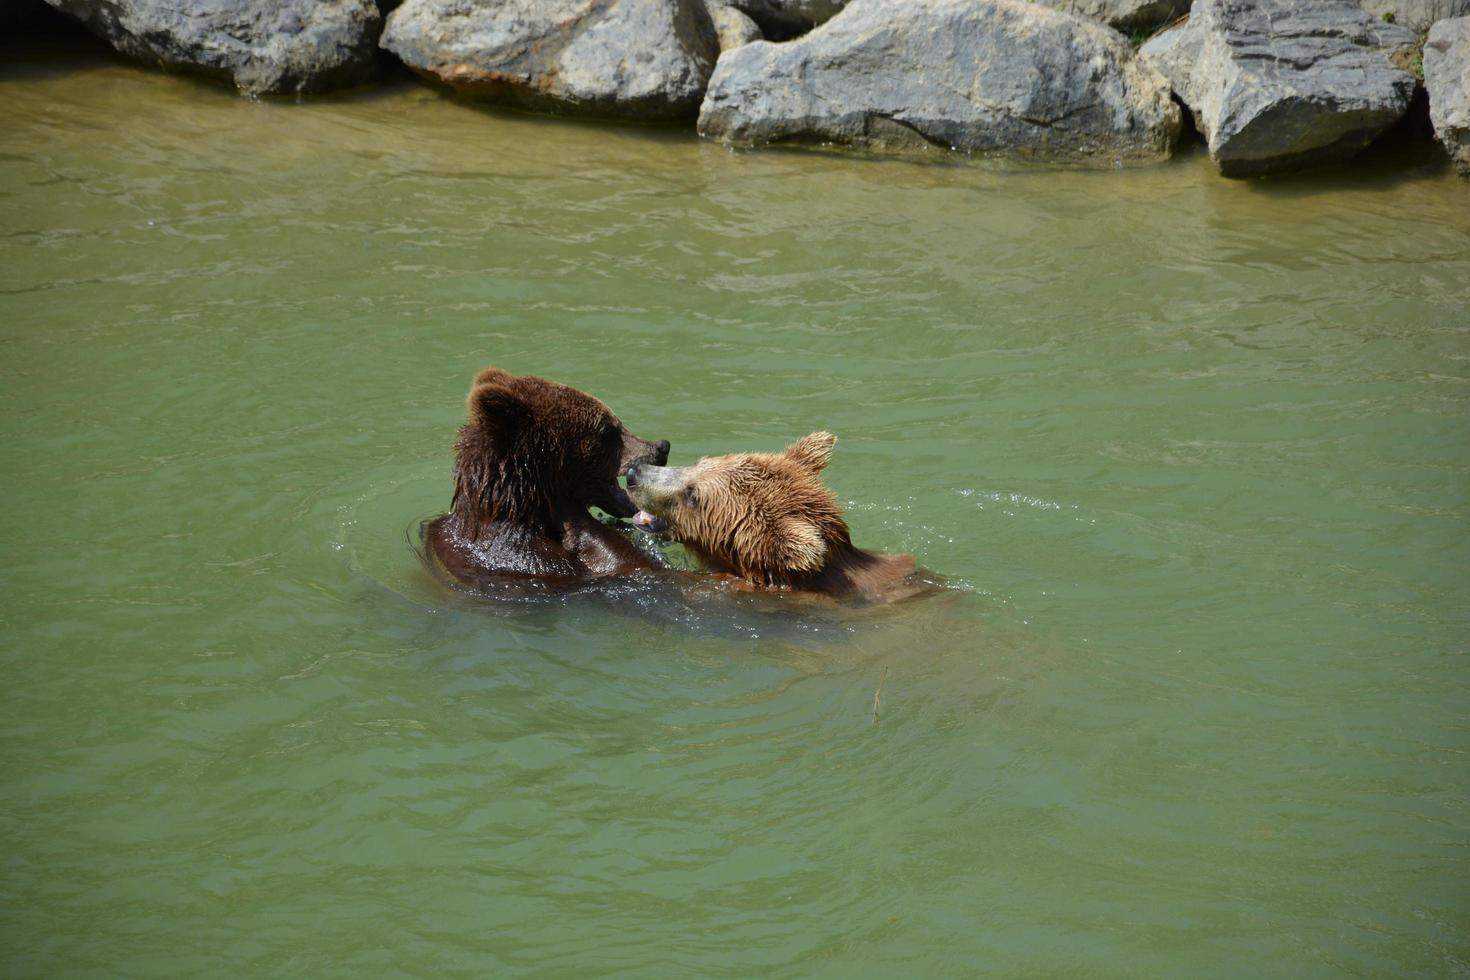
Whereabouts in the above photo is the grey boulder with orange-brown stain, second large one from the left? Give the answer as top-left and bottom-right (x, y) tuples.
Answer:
(382, 0), (719, 119)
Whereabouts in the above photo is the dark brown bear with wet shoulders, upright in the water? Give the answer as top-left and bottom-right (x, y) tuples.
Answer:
(422, 367), (669, 585)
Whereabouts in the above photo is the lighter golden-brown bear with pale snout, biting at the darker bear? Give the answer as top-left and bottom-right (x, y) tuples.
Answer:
(626, 432), (933, 602)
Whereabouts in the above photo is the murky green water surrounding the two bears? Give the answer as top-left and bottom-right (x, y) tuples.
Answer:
(0, 34), (1470, 977)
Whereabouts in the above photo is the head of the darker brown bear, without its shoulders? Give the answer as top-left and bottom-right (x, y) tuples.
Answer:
(451, 367), (669, 539)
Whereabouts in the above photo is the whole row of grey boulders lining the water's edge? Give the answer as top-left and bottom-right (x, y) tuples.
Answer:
(14, 0), (1470, 179)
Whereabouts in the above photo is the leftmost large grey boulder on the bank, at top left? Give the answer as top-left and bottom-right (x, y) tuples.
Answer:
(47, 0), (382, 96)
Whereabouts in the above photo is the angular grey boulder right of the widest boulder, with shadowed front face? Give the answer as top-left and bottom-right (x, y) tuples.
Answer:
(1139, 0), (1414, 178)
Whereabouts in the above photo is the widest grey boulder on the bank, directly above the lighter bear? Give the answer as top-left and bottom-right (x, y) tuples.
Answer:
(700, 0), (1182, 160)
